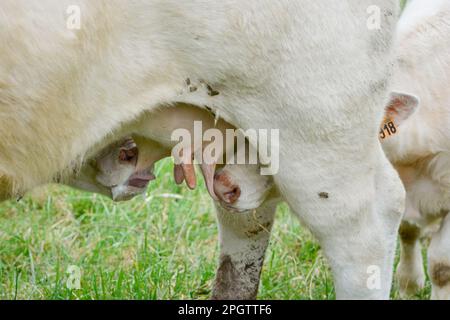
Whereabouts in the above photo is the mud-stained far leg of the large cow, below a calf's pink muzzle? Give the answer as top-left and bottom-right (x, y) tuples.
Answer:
(212, 200), (278, 300)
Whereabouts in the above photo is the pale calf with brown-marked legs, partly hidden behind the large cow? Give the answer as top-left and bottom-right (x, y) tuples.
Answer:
(383, 0), (450, 299)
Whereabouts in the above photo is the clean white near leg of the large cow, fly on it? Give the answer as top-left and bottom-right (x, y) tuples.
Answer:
(276, 145), (404, 299)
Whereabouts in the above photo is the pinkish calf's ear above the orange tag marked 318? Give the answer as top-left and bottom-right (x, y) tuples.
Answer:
(385, 92), (419, 126)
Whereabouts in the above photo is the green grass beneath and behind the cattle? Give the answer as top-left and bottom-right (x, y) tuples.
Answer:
(0, 161), (430, 299)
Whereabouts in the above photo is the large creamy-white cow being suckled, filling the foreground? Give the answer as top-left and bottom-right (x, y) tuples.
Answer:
(0, 0), (404, 299)
